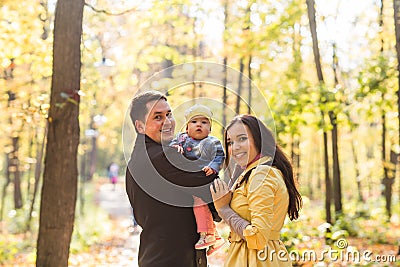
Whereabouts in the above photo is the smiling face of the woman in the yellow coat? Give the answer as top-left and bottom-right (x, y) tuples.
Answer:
(226, 122), (259, 167)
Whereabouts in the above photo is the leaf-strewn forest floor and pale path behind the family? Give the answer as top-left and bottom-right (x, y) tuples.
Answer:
(0, 179), (400, 267)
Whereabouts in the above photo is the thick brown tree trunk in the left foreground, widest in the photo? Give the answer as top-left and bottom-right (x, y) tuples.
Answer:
(36, 0), (84, 267)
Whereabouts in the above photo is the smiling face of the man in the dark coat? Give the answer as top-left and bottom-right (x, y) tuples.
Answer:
(135, 99), (175, 144)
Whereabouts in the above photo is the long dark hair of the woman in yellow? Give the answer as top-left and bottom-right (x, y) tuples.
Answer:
(224, 115), (302, 220)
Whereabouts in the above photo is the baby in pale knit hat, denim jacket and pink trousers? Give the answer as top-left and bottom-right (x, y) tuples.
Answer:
(170, 104), (225, 255)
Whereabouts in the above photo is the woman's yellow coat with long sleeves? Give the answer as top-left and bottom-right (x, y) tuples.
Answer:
(224, 157), (292, 267)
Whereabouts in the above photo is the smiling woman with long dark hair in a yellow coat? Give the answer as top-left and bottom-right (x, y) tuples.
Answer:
(210, 115), (302, 267)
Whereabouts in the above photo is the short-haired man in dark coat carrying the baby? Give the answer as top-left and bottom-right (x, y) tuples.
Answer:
(126, 91), (217, 267)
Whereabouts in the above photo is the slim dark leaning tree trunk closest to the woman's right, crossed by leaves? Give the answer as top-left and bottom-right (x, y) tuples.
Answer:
(306, 0), (332, 223)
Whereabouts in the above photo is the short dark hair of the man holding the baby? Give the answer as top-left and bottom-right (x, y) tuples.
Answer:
(129, 91), (167, 132)
